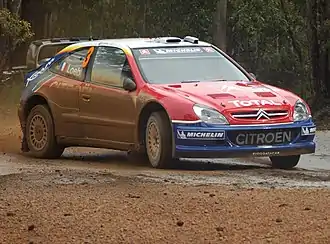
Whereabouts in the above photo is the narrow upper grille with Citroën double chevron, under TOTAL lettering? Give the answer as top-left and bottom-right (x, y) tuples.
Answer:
(231, 109), (289, 120)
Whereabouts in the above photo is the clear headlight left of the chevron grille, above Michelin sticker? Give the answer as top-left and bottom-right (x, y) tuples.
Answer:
(193, 104), (228, 125)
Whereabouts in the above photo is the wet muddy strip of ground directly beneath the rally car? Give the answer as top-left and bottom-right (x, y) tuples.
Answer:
(0, 144), (330, 188)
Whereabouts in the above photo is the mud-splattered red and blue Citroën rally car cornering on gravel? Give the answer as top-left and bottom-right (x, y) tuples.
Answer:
(18, 36), (316, 169)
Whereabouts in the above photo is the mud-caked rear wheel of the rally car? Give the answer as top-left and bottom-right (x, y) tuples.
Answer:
(26, 105), (64, 159)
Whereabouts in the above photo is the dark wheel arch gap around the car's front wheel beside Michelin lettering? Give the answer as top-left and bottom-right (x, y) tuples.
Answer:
(136, 101), (174, 152)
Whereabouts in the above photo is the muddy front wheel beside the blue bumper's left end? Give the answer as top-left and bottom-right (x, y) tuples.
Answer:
(145, 111), (172, 169)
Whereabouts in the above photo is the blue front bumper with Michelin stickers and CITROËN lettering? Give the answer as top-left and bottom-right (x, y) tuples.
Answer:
(172, 120), (316, 158)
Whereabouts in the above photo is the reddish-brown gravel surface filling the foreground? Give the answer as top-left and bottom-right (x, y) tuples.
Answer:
(0, 171), (330, 243)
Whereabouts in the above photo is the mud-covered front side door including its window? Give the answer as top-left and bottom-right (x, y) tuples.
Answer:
(80, 46), (136, 149)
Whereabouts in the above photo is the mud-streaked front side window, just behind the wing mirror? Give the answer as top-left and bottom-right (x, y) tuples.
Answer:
(91, 47), (133, 87)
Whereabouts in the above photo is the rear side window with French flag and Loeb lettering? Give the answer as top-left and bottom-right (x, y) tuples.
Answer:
(51, 48), (90, 80)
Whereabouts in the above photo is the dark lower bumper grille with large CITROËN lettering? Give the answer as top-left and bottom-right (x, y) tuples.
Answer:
(227, 128), (300, 146)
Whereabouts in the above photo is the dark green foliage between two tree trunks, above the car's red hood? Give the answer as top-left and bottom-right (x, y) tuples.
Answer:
(228, 0), (310, 96)
